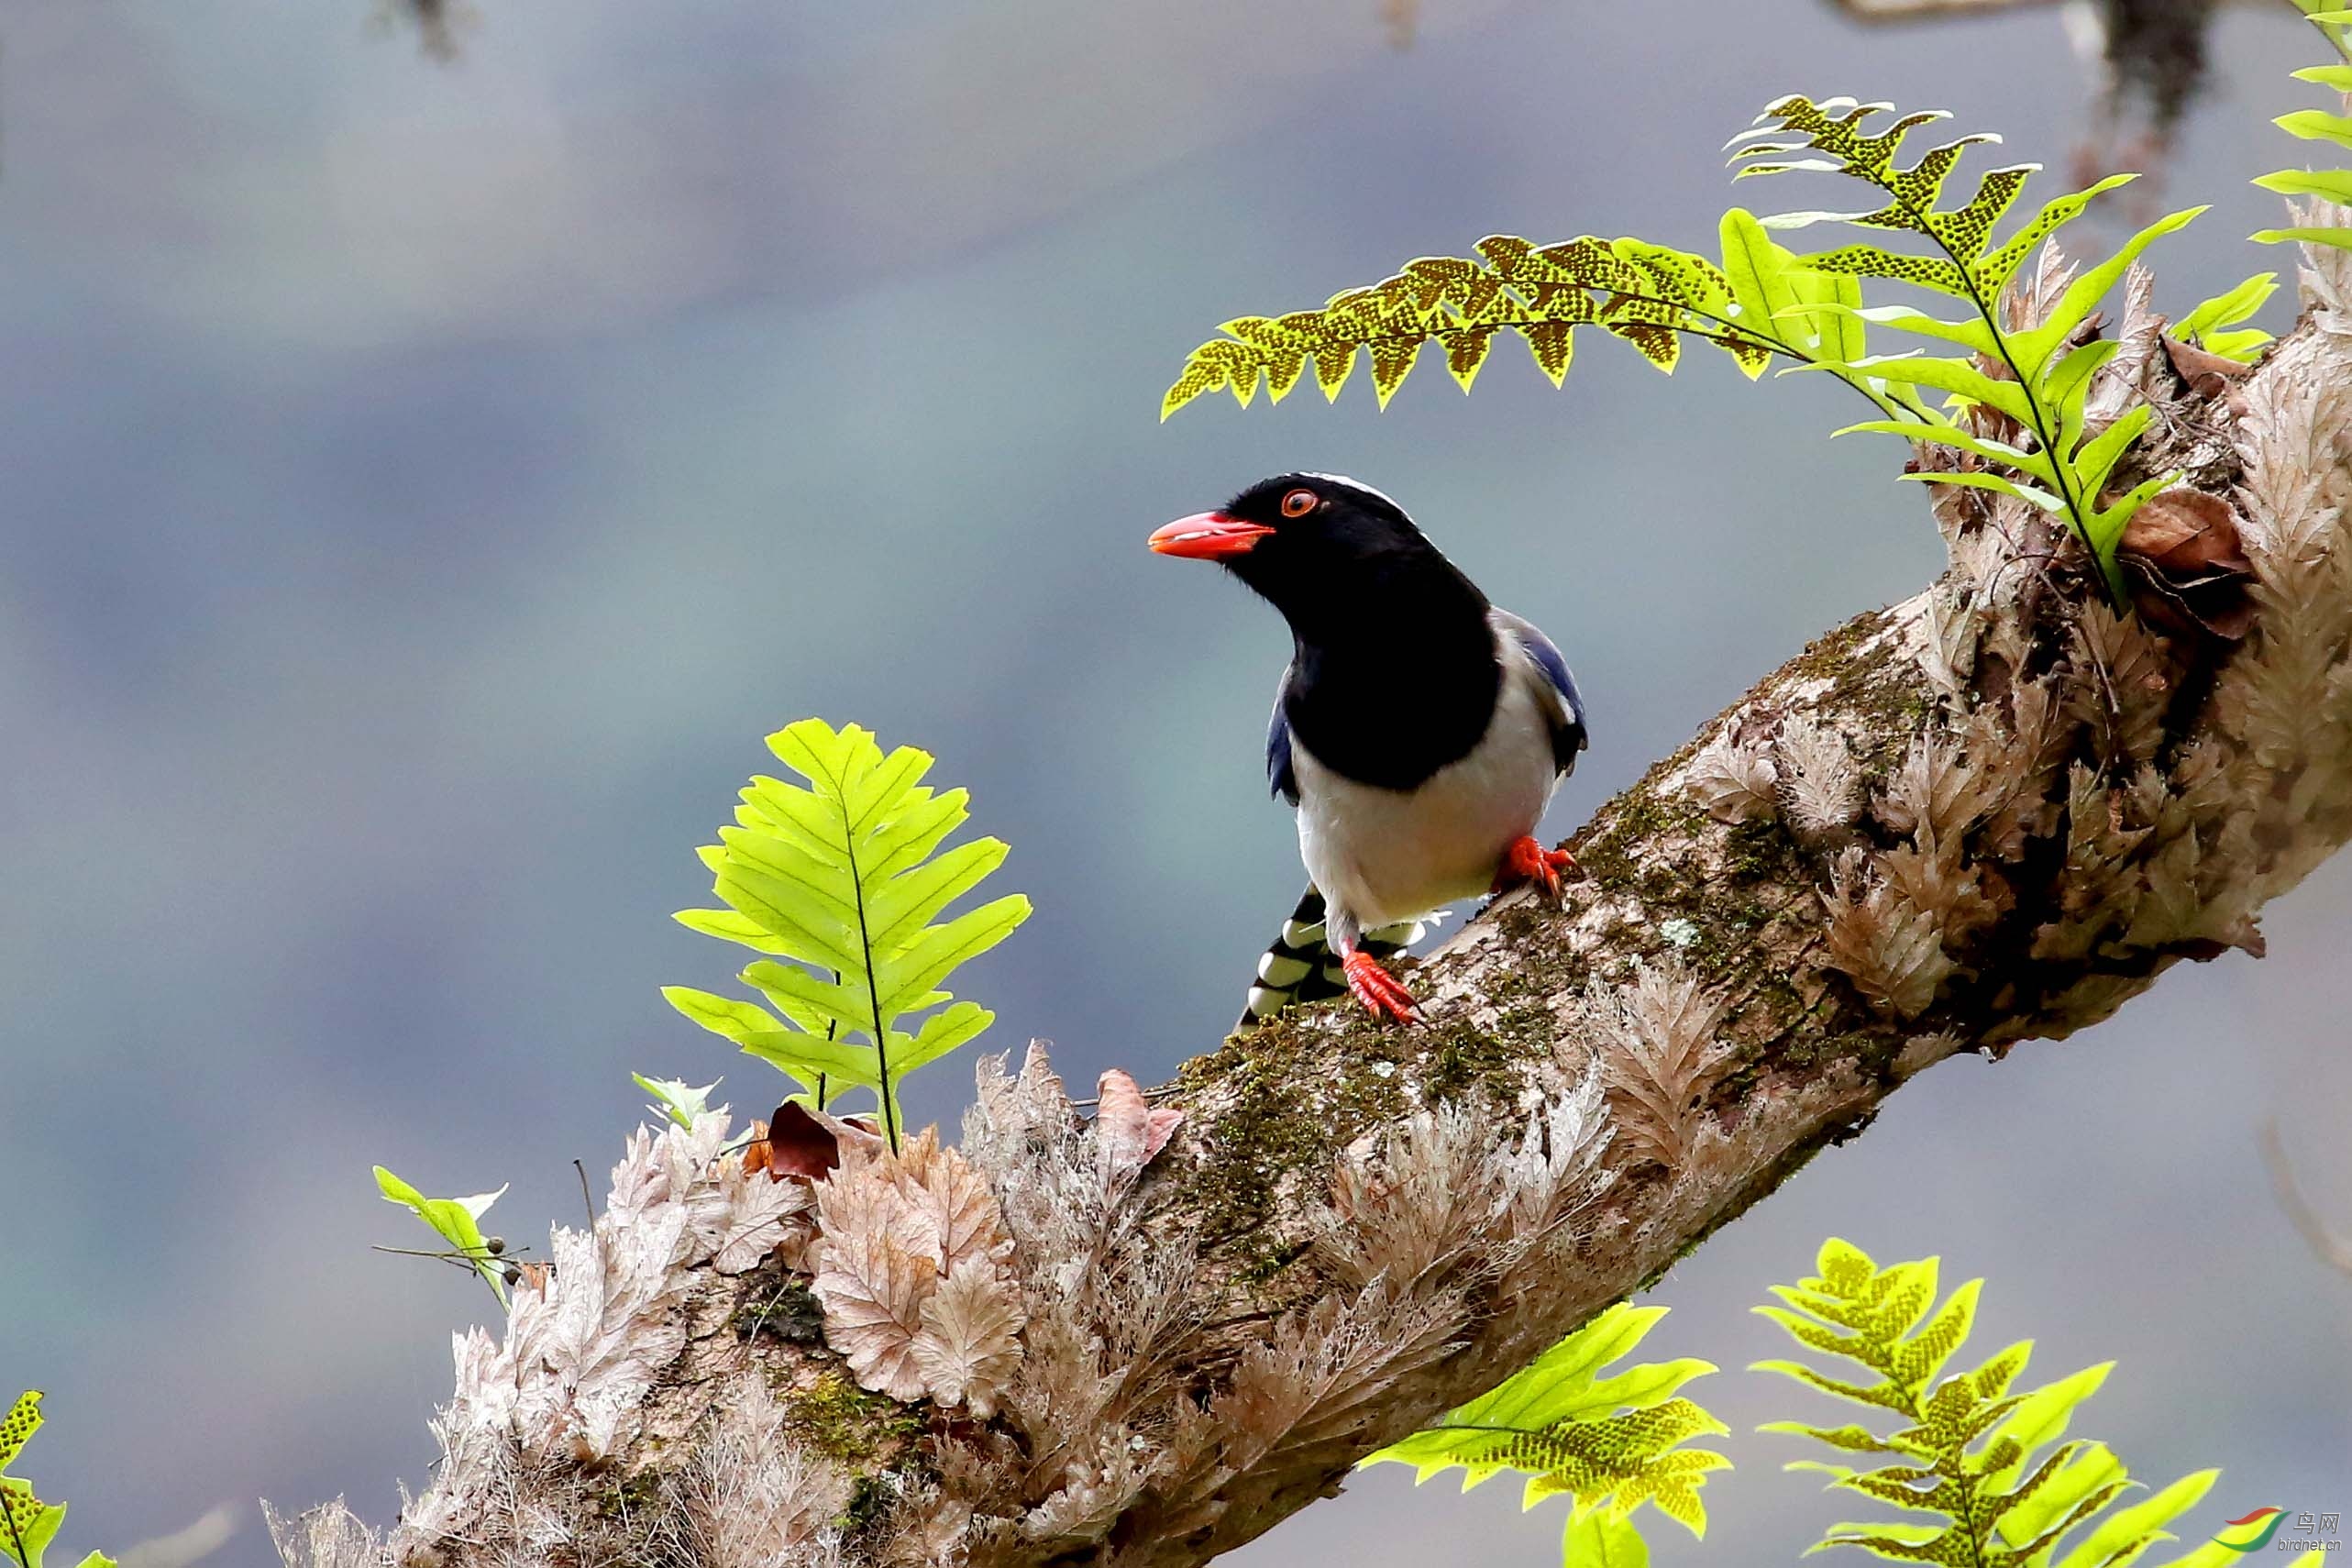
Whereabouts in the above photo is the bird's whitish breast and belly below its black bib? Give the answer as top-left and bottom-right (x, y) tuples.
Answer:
(1291, 642), (1557, 926)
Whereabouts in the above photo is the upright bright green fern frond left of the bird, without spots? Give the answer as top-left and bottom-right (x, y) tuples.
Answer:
(663, 719), (1030, 1150)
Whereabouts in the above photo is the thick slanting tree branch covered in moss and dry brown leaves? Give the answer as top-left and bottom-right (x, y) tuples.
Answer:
(275, 254), (2352, 1568)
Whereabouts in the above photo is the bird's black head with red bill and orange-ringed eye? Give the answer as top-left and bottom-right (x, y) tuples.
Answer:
(1150, 472), (1486, 639)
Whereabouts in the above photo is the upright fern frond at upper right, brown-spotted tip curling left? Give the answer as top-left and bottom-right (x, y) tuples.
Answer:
(1733, 96), (2203, 602)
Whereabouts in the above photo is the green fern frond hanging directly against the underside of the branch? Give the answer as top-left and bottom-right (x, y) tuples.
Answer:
(1364, 1302), (1731, 1568)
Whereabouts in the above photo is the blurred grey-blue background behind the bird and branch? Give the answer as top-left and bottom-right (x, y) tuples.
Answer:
(0, 0), (2352, 1568)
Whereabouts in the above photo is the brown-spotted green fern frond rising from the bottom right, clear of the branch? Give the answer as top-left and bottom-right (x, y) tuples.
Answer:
(1754, 1239), (2236, 1568)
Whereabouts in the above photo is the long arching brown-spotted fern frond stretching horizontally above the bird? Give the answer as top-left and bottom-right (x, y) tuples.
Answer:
(1160, 212), (1898, 418)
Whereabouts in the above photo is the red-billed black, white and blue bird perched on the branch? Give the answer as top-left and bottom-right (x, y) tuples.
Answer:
(1150, 472), (1585, 1025)
